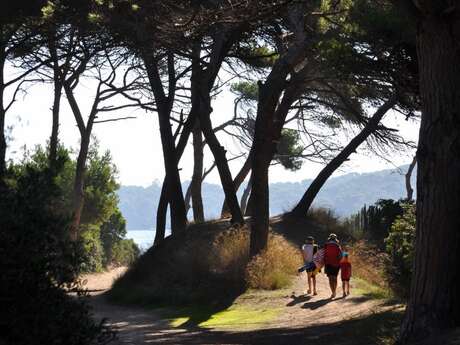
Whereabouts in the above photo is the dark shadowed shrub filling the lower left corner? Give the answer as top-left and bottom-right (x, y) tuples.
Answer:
(0, 156), (109, 345)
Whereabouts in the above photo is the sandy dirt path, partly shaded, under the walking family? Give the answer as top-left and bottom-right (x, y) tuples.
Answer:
(88, 268), (398, 345)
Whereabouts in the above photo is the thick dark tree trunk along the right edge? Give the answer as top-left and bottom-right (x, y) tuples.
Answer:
(401, 9), (460, 343)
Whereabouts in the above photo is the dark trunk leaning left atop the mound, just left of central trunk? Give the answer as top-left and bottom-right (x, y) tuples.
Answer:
(197, 86), (244, 224)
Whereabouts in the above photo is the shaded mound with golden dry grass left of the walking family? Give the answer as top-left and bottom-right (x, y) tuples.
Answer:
(110, 222), (301, 307)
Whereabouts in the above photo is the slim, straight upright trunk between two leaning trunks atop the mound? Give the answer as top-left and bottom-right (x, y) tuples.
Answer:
(190, 121), (204, 223)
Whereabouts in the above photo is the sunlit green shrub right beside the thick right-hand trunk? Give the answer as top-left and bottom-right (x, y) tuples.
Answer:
(385, 203), (415, 297)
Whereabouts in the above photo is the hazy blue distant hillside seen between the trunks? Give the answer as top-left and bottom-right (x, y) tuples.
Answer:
(118, 166), (415, 230)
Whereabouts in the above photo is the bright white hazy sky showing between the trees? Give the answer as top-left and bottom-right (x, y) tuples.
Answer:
(7, 68), (418, 186)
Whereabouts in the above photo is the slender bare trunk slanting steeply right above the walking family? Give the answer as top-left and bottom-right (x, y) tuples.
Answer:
(291, 95), (397, 217)
